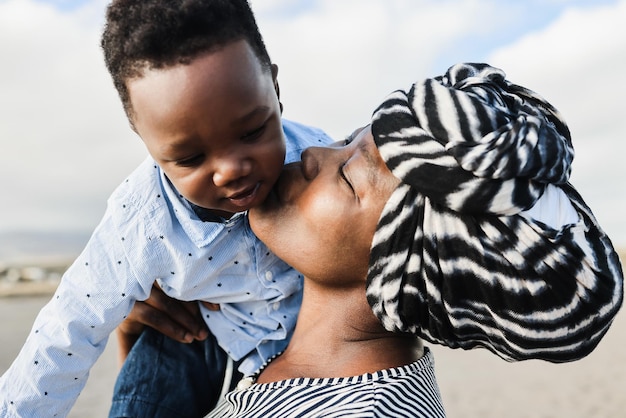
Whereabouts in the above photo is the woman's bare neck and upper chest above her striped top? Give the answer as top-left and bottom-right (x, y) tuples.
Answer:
(257, 279), (422, 383)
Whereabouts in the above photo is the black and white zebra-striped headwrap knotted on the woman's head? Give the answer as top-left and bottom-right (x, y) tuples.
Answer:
(367, 64), (623, 362)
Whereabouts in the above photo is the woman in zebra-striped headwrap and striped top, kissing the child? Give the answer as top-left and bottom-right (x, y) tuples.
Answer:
(205, 64), (623, 417)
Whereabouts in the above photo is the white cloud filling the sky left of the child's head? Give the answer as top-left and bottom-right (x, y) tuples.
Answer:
(0, 0), (145, 230)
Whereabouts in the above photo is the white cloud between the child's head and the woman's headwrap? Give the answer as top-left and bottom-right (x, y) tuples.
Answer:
(254, 0), (506, 137)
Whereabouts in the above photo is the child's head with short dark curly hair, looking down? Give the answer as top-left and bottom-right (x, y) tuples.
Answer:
(102, 0), (285, 217)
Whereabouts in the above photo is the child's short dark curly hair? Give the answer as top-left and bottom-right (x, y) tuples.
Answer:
(101, 0), (271, 122)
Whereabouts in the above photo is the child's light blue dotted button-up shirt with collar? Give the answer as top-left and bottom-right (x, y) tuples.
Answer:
(0, 121), (331, 417)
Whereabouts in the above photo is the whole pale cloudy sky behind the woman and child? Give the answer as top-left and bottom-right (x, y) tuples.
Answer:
(0, 0), (626, 248)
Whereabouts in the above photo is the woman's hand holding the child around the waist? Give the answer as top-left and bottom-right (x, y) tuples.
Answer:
(117, 283), (219, 364)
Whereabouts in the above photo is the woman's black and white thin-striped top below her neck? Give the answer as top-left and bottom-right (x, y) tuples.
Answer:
(207, 348), (446, 418)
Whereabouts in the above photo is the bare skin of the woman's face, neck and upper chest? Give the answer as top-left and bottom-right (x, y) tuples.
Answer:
(249, 128), (423, 383)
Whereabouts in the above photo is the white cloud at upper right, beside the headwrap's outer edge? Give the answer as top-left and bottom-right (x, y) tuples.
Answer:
(489, 0), (626, 248)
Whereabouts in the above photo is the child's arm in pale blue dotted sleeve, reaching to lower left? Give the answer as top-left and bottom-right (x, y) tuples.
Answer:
(0, 212), (151, 417)
